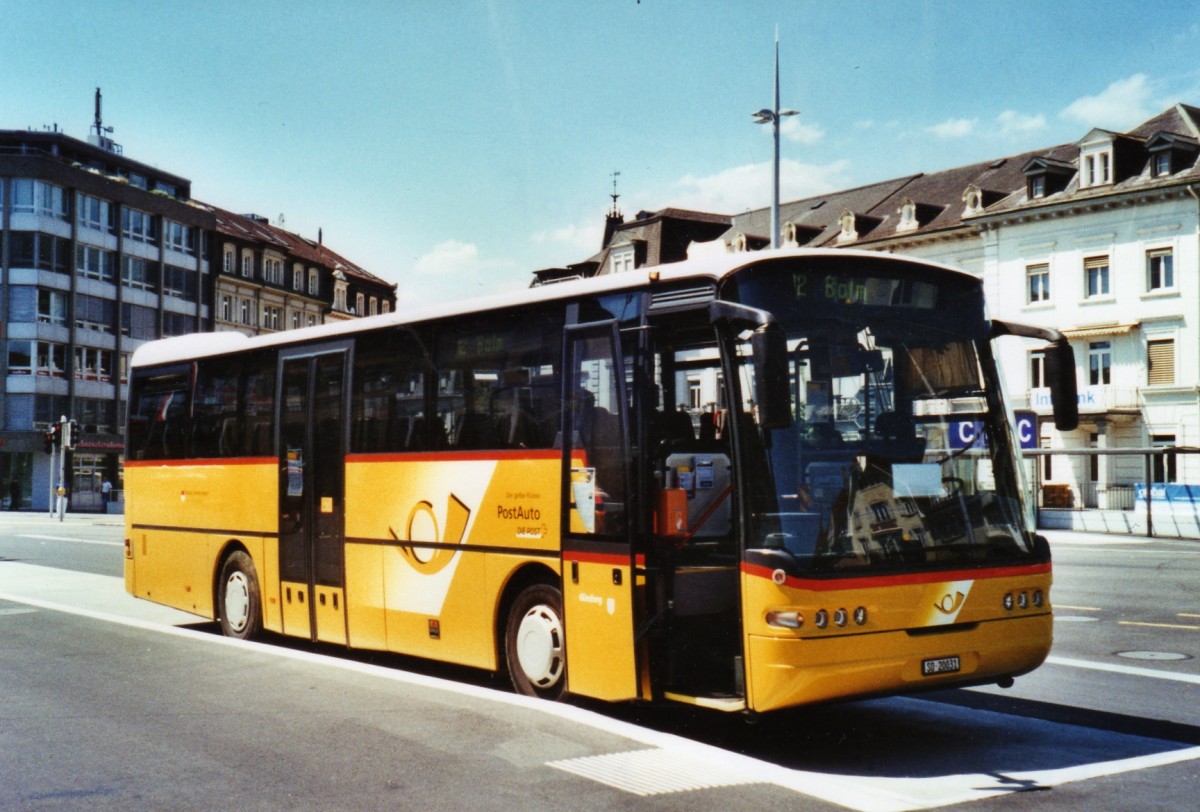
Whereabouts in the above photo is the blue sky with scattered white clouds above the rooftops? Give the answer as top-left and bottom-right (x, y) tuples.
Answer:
(0, 0), (1200, 305)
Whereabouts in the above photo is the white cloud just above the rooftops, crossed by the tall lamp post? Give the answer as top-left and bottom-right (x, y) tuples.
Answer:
(668, 158), (847, 215)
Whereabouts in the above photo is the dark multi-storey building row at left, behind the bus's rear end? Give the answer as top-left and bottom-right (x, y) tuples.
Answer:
(0, 130), (395, 510)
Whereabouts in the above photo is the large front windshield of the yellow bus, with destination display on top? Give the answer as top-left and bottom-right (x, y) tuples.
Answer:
(726, 257), (1037, 576)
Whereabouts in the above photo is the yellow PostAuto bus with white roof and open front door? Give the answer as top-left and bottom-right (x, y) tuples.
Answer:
(125, 249), (1078, 712)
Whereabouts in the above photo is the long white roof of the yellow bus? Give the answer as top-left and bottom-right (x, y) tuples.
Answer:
(131, 248), (970, 367)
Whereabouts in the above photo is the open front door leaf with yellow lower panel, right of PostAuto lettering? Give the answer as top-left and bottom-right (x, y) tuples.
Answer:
(563, 321), (644, 700)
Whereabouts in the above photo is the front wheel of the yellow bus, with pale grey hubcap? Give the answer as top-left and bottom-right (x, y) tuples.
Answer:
(504, 584), (566, 700)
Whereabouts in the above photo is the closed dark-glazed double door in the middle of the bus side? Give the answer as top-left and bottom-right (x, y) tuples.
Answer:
(278, 345), (347, 643)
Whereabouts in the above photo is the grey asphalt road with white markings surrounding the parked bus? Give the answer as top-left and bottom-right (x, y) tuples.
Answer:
(0, 513), (1200, 811)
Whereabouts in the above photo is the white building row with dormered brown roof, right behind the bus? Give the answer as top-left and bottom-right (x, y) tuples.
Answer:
(556, 104), (1200, 507)
